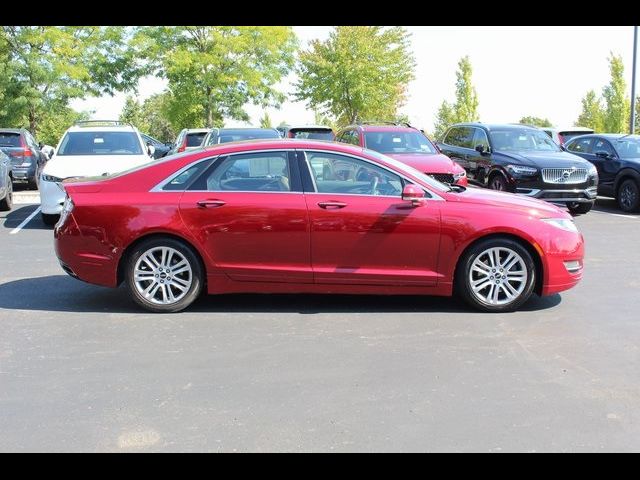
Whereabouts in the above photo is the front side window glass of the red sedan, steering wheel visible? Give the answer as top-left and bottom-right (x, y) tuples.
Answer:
(306, 152), (402, 197)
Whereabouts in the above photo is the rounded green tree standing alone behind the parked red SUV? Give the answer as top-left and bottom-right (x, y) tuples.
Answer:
(294, 26), (415, 125)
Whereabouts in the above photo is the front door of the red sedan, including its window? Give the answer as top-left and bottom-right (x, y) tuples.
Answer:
(301, 151), (440, 286)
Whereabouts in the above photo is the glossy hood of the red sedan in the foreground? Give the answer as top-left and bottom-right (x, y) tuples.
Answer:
(448, 188), (571, 218)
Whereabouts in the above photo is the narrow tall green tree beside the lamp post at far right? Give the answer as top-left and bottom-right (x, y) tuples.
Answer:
(602, 54), (631, 133)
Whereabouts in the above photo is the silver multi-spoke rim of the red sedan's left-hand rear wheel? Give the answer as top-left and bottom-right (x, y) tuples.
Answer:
(133, 247), (193, 305)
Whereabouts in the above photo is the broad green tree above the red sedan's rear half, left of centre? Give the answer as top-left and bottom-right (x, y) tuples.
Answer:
(132, 26), (297, 129)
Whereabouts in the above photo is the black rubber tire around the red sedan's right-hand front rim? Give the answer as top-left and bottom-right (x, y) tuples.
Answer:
(455, 237), (538, 312)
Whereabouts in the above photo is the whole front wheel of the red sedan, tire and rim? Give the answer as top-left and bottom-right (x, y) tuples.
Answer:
(456, 237), (536, 312)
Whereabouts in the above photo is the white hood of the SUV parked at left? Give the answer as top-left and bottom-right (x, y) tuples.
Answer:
(42, 155), (153, 178)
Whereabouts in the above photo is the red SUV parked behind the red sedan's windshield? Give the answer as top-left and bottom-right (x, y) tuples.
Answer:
(336, 122), (468, 187)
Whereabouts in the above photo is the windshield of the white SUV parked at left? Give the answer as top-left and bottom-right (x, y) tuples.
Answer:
(58, 132), (142, 156)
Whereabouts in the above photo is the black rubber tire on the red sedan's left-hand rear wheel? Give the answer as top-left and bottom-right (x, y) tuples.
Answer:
(124, 237), (204, 313)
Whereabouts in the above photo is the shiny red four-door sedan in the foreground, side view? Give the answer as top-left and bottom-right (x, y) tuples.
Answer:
(54, 139), (584, 312)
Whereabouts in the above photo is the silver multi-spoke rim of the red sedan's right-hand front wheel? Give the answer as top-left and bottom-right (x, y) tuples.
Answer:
(469, 247), (528, 305)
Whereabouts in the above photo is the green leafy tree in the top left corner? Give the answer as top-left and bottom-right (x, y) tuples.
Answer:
(0, 26), (141, 135)
